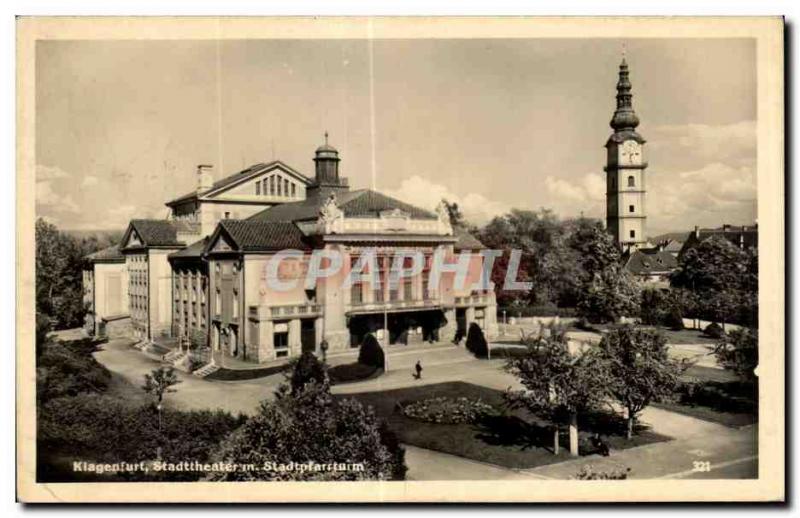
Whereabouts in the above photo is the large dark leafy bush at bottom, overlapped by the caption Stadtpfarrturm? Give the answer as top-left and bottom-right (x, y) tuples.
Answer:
(209, 381), (405, 481)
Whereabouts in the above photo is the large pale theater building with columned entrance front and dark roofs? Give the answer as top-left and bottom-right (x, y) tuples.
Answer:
(108, 136), (497, 363)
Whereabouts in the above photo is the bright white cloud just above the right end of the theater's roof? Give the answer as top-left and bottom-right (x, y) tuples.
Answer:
(385, 175), (510, 225)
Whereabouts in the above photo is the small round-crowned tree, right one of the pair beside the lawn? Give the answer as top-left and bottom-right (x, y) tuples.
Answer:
(600, 326), (681, 439)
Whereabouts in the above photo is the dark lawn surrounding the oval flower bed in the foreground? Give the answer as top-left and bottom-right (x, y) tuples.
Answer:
(336, 382), (669, 469)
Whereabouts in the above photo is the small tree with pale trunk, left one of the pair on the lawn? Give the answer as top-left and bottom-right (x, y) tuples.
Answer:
(506, 329), (611, 455)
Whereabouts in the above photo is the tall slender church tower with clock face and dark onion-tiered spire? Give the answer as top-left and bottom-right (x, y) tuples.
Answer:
(605, 57), (647, 251)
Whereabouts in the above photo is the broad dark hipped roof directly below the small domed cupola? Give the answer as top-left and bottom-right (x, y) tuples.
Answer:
(248, 189), (436, 221)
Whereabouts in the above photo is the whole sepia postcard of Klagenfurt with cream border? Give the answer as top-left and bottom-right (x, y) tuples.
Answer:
(17, 17), (785, 502)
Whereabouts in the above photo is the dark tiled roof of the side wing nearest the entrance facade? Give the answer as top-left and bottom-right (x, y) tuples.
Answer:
(220, 219), (310, 252)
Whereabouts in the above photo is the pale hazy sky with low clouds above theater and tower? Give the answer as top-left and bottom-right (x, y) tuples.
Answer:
(36, 39), (756, 236)
